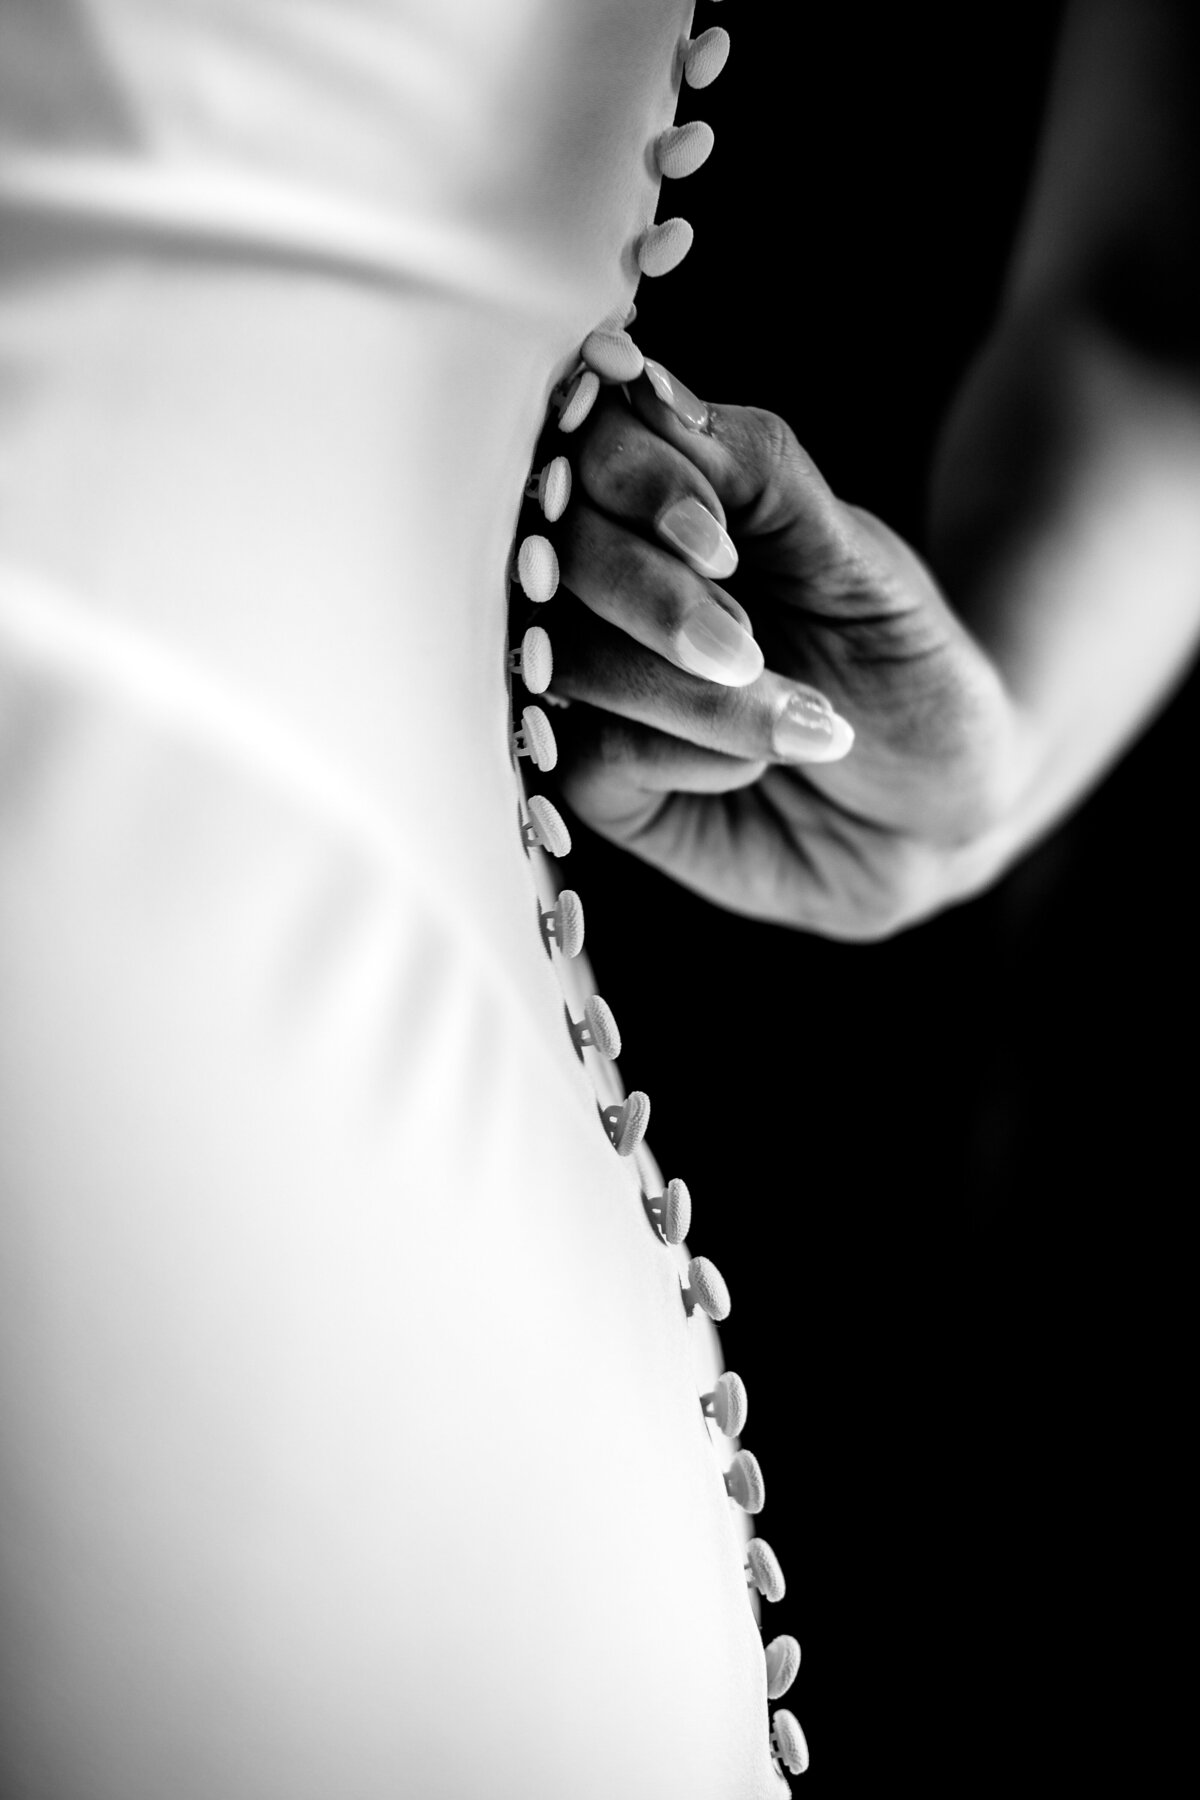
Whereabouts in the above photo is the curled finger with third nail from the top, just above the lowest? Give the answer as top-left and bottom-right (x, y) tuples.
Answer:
(560, 500), (763, 686)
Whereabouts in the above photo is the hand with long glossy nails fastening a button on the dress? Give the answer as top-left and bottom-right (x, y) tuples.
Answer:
(552, 364), (1020, 938)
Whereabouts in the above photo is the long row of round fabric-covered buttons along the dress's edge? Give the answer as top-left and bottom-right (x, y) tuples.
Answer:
(509, 3), (808, 1775)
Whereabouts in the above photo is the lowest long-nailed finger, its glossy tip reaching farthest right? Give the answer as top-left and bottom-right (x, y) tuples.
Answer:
(554, 607), (855, 769)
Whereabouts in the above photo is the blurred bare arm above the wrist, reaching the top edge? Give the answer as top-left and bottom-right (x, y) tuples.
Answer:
(930, 0), (1200, 885)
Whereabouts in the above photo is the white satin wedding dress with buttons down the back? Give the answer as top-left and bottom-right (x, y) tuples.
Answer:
(0, 0), (804, 1800)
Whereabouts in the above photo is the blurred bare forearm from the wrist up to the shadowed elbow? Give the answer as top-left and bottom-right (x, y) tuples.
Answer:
(930, 306), (1200, 877)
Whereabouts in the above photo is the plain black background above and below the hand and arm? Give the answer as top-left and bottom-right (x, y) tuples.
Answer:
(554, 4), (1196, 1800)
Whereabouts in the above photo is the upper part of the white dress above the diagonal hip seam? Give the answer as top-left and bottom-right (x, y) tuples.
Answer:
(0, 0), (689, 986)
